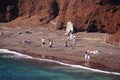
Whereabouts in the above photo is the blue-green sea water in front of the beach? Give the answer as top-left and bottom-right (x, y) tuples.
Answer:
(0, 51), (120, 80)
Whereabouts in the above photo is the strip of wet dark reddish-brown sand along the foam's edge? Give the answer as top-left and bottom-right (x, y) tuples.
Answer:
(24, 53), (120, 75)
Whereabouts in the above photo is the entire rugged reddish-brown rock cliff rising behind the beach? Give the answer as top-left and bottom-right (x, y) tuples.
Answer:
(0, 0), (120, 43)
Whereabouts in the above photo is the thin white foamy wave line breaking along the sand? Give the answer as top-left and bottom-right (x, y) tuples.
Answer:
(0, 49), (120, 75)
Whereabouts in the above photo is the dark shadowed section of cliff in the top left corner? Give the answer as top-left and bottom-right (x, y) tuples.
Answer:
(0, 0), (19, 22)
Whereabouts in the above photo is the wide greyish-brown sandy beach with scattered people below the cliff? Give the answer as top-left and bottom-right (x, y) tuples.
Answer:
(0, 26), (120, 72)
